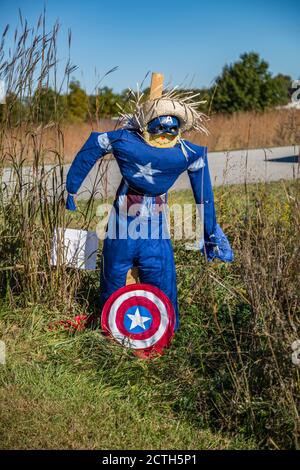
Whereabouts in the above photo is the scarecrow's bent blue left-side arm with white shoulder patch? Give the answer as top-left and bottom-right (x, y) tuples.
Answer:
(66, 132), (112, 211)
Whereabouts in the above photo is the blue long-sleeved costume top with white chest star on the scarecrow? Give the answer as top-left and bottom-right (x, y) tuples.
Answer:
(66, 129), (233, 262)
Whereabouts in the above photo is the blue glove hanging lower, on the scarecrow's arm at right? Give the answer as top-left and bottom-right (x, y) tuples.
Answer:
(200, 224), (234, 263)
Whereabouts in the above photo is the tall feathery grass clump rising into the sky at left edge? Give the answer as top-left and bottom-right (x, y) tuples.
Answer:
(0, 13), (107, 306)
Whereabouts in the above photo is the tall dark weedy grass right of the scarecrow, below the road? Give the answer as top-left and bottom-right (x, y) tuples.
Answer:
(172, 182), (300, 448)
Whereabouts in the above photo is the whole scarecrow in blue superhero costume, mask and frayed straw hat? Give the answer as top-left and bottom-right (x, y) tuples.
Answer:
(66, 74), (233, 352)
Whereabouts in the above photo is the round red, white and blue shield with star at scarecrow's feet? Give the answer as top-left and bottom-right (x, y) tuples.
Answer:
(101, 284), (175, 356)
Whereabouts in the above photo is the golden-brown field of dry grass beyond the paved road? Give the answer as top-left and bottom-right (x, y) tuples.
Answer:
(3, 109), (300, 165)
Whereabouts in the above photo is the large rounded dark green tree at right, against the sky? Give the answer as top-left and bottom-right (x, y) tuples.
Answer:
(212, 52), (291, 113)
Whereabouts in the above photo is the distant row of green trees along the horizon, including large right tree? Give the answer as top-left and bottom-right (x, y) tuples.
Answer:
(0, 52), (292, 124)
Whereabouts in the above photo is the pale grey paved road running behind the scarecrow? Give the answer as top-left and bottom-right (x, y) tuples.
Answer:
(2, 146), (300, 199)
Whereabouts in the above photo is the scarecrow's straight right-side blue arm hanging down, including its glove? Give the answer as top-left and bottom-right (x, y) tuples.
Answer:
(188, 147), (233, 262)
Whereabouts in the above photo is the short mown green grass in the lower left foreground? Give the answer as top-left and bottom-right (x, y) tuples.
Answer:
(0, 307), (254, 449)
